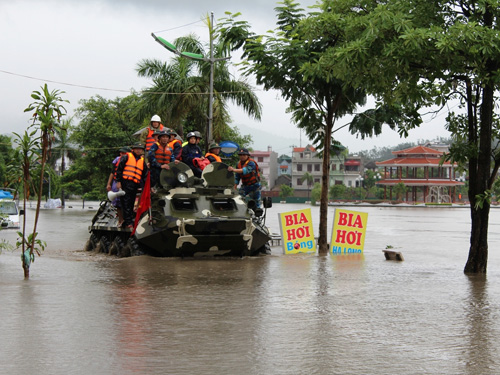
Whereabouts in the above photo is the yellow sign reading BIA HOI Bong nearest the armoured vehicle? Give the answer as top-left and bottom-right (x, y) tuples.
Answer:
(278, 208), (316, 254)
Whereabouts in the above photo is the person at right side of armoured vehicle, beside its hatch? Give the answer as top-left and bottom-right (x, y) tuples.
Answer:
(227, 148), (261, 207)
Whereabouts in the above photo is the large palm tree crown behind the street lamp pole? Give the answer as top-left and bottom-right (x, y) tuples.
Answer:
(136, 30), (262, 142)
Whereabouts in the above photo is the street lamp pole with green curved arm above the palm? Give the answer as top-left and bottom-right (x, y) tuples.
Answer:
(151, 12), (231, 146)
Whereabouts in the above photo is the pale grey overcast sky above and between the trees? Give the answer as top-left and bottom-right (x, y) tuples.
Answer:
(0, 0), (449, 153)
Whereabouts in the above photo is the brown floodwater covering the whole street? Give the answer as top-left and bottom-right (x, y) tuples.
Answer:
(0, 204), (500, 375)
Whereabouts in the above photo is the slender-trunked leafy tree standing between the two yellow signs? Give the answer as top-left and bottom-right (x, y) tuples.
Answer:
(218, 0), (372, 253)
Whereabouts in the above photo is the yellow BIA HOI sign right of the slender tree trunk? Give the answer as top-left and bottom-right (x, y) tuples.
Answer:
(330, 209), (368, 255)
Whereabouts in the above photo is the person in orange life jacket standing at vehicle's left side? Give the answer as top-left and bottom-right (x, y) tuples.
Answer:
(116, 143), (148, 228)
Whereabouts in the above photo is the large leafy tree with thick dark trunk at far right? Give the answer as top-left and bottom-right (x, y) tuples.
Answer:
(311, 0), (500, 273)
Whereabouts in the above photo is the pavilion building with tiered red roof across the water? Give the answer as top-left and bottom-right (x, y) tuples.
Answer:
(376, 146), (464, 203)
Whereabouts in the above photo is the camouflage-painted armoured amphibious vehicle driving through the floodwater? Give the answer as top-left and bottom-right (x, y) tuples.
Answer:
(85, 163), (272, 257)
